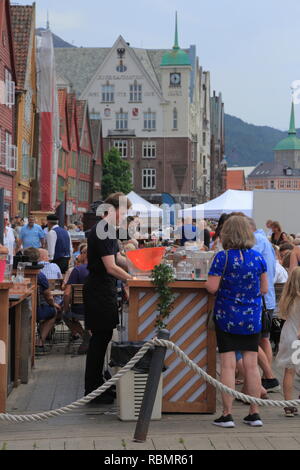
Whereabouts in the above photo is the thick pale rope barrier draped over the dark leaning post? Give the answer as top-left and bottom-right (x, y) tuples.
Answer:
(0, 338), (300, 423)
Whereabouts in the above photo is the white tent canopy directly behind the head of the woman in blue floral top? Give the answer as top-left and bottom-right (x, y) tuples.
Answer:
(179, 189), (253, 219)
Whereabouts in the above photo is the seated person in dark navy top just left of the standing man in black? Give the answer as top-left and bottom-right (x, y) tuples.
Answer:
(63, 246), (90, 354)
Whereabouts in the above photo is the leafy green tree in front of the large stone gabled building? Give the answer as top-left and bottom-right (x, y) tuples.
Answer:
(102, 148), (133, 199)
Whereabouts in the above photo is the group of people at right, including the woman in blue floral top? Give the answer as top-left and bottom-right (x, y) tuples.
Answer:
(207, 213), (300, 428)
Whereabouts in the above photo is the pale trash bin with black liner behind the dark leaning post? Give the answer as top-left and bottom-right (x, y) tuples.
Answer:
(110, 342), (163, 421)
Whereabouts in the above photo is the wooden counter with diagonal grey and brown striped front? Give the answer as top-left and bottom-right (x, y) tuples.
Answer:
(128, 280), (216, 413)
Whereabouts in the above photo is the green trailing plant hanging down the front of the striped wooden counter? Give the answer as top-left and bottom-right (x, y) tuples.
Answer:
(152, 264), (175, 330)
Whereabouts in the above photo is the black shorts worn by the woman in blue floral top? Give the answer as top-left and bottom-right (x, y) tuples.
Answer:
(216, 326), (260, 354)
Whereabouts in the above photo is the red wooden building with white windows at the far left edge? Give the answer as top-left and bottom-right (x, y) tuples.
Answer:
(0, 0), (17, 215)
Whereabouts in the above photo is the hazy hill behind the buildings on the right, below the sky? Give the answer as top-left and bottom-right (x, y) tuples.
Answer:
(225, 114), (287, 166)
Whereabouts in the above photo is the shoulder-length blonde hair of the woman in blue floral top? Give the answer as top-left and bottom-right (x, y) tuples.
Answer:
(221, 215), (255, 250)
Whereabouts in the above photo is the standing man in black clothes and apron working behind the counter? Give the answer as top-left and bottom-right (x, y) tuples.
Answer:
(84, 193), (132, 404)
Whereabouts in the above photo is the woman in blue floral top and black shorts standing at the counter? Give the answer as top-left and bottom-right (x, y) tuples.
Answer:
(206, 216), (268, 428)
